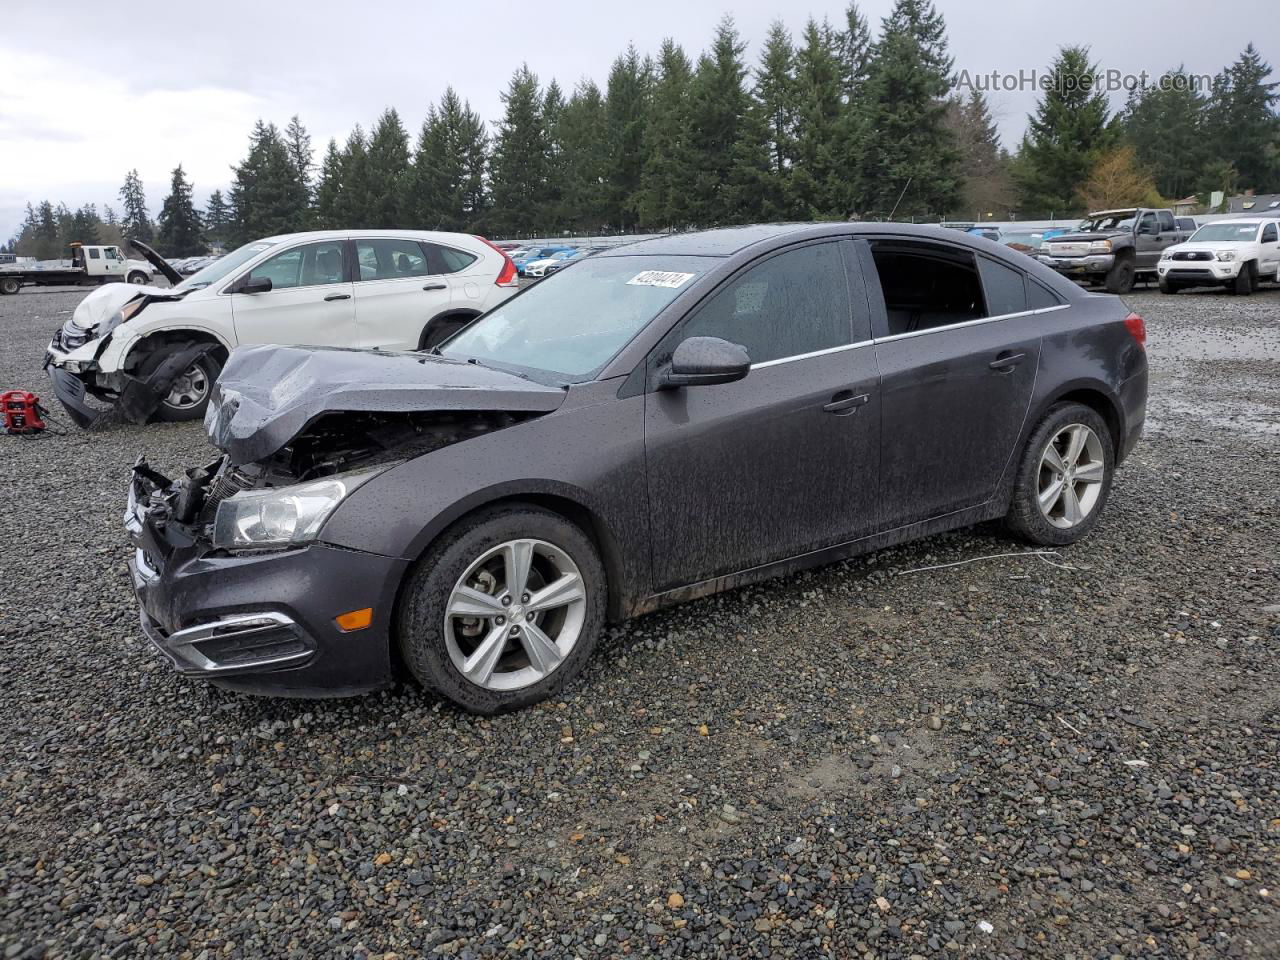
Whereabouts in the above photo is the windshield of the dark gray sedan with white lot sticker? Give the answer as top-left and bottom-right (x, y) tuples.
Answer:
(440, 256), (714, 383)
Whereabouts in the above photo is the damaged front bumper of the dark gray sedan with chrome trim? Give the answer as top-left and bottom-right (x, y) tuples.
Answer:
(124, 471), (408, 696)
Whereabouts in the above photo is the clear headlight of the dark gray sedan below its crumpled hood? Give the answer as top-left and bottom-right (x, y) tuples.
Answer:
(214, 467), (387, 550)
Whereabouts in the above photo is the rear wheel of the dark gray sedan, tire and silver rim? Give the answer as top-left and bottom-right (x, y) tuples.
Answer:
(1005, 403), (1115, 547)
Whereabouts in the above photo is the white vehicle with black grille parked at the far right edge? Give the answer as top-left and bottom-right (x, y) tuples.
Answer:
(1156, 218), (1280, 296)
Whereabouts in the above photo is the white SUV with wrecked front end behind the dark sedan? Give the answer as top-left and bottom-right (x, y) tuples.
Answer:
(45, 230), (518, 426)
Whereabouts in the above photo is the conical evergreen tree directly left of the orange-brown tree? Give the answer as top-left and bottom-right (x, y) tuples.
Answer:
(1014, 46), (1119, 216)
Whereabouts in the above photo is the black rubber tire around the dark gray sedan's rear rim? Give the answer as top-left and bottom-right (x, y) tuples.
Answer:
(1005, 403), (1115, 547)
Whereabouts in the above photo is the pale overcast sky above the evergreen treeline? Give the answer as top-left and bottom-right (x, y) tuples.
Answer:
(0, 0), (1280, 244)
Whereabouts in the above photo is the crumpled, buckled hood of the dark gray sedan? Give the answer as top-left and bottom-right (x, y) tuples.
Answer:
(205, 344), (564, 465)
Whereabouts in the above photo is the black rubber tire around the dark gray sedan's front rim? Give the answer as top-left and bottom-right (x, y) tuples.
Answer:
(396, 503), (607, 714)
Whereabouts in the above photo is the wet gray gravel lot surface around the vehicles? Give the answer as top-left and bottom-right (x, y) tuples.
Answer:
(0, 281), (1280, 959)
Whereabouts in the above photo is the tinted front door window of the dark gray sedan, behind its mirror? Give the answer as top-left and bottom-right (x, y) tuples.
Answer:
(680, 242), (852, 364)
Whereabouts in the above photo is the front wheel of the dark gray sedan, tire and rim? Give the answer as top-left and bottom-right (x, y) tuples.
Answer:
(397, 504), (605, 714)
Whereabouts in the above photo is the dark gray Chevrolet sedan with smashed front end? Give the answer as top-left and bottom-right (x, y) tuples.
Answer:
(125, 224), (1147, 713)
